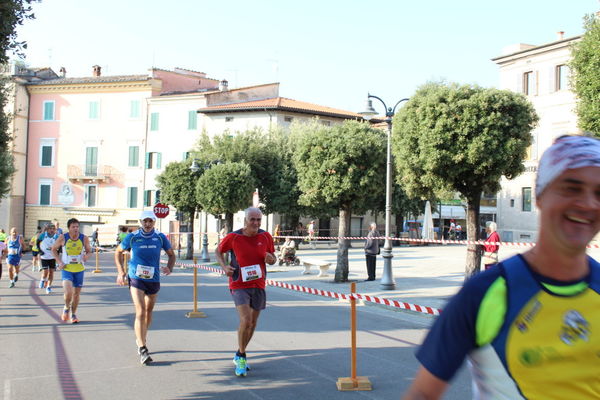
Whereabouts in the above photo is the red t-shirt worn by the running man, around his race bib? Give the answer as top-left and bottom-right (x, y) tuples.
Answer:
(218, 229), (275, 289)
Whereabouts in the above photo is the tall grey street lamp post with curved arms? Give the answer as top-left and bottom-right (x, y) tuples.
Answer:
(359, 93), (408, 290)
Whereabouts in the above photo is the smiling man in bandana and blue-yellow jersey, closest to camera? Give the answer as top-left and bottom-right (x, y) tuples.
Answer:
(403, 136), (600, 400)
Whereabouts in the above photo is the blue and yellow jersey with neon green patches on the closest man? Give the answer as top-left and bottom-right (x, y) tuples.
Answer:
(417, 256), (600, 400)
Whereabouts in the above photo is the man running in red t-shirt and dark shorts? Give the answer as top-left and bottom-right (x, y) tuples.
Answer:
(215, 207), (277, 376)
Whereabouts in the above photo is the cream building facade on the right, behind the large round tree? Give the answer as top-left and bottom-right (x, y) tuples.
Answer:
(492, 32), (581, 242)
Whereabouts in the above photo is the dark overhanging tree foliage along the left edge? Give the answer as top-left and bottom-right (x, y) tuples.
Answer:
(0, 0), (34, 199)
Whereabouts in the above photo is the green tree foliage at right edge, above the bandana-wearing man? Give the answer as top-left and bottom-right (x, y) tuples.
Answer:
(569, 15), (600, 137)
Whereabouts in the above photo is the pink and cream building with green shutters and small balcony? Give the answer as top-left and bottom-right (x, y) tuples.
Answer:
(25, 66), (218, 233)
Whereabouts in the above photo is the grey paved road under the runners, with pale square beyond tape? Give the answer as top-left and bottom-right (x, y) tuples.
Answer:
(7, 242), (596, 400)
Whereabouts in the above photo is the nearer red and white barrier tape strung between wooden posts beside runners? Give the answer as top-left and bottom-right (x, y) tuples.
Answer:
(171, 261), (442, 315)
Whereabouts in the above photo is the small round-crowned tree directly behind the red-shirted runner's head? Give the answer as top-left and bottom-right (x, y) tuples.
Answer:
(196, 162), (256, 229)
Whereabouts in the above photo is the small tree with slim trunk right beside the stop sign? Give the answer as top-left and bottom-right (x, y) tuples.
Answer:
(156, 160), (198, 260)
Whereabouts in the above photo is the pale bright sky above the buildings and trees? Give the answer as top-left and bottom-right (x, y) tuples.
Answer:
(10, 0), (600, 112)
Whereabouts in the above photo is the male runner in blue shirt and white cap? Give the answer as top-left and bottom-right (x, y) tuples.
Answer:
(115, 211), (175, 365)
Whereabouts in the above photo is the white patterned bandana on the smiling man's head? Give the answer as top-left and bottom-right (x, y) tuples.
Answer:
(535, 136), (600, 197)
